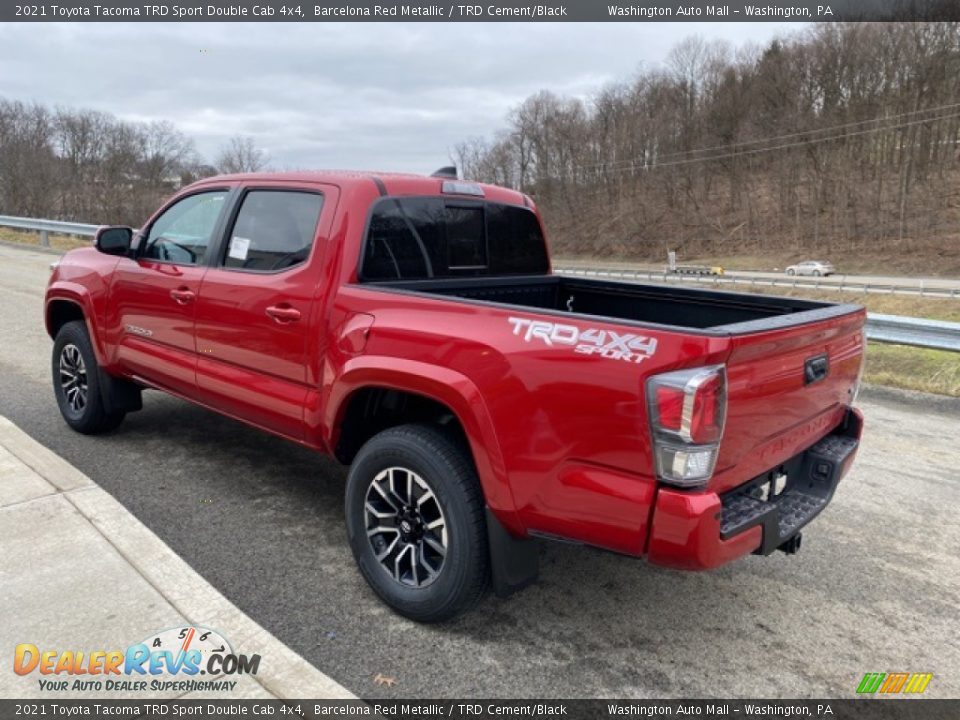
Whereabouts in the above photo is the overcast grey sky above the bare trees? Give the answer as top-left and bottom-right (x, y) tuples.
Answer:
(0, 23), (798, 172)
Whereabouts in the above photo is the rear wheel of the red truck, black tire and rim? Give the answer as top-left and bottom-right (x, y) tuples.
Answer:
(346, 425), (489, 622)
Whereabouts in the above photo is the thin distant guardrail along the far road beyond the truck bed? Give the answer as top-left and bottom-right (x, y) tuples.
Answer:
(554, 267), (960, 298)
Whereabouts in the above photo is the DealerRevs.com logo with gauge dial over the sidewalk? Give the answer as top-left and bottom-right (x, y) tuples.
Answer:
(13, 626), (260, 692)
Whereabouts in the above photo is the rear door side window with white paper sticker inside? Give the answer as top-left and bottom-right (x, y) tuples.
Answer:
(223, 190), (323, 272)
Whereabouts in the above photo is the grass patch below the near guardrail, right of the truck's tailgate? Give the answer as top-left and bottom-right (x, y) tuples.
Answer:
(863, 343), (960, 397)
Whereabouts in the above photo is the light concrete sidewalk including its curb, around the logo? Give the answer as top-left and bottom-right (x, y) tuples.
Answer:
(0, 416), (353, 699)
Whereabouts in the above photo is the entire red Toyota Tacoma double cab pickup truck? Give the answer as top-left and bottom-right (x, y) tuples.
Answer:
(46, 171), (865, 621)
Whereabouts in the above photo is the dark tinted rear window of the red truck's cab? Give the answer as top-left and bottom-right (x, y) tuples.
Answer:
(360, 198), (548, 280)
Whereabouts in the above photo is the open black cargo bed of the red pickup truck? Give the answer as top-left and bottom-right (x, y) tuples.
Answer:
(365, 275), (859, 335)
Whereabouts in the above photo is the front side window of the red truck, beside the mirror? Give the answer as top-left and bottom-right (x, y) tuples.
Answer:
(142, 190), (227, 265)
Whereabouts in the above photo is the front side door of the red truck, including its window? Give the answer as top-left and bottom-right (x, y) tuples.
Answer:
(106, 189), (229, 395)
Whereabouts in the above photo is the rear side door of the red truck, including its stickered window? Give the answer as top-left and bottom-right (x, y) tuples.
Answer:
(189, 184), (336, 439)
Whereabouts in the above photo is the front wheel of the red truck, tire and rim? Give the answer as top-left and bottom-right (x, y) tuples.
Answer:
(51, 320), (126, 435)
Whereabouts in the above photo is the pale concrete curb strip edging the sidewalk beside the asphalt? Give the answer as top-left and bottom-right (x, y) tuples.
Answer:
(0, 416), (356, 700)
